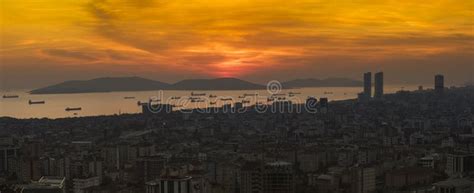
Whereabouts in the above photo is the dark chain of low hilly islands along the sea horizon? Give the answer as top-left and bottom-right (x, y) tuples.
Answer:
(30, 77), (362, 94)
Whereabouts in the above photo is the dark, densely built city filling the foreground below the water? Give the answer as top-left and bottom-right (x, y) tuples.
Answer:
(0, 73), (474, 193)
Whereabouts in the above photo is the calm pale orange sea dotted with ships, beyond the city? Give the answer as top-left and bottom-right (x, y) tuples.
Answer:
(0, 85), (426, 118)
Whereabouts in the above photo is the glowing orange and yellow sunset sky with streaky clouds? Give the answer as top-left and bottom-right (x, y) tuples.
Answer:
(0, 0), (474, 88)
